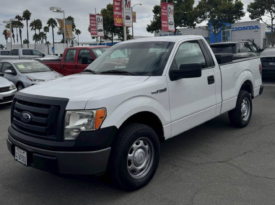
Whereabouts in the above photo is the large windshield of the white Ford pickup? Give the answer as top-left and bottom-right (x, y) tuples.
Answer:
(87, 42), (174, 76)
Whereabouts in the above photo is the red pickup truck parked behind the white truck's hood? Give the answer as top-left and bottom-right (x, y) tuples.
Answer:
(40, 46), (108, 75)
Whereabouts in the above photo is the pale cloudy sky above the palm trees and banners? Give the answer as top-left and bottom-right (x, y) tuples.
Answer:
(0, 0), (258, 44)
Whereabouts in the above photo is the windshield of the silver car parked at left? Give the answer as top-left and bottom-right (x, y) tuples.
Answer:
(14, 61), (51, 73)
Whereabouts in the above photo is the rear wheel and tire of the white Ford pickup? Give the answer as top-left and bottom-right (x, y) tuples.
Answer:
(228, 90), (253, 128)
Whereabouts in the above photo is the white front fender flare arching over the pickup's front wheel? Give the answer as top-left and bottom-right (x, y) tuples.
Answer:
(102, 96), (171, 133)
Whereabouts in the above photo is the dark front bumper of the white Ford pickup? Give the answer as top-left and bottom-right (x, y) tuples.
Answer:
(7, 135), (111, 175)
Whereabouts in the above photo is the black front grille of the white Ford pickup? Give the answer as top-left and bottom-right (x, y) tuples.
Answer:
(12, 93), (67, 140)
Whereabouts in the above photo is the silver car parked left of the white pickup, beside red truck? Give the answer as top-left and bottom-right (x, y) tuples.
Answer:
(0, 60), (62, 90)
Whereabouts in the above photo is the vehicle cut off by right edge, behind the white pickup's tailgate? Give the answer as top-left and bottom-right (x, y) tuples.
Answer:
(261, 48), (275, 77)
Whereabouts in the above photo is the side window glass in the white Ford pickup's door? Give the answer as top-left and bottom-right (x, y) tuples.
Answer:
(171, 41), (206, 70)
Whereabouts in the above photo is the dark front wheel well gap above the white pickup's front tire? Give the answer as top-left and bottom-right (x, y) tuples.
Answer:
(122, 112), (165, 142)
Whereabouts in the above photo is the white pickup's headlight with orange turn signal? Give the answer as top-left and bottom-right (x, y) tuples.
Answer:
(64, 109), (106, 140)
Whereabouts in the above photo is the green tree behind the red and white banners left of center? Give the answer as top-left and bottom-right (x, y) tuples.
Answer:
(101, 4), (131, 45)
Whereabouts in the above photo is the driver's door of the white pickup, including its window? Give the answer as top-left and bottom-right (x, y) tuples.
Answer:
(168, 40), (217, 137)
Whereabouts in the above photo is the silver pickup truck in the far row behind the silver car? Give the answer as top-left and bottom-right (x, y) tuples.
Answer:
(0, 48), (58, 60)
